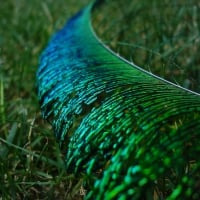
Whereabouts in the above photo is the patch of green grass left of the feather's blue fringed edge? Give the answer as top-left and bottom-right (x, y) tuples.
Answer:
(0, 0), (88, 199)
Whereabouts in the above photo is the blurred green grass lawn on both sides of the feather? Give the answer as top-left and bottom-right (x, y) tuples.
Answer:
(0, 0), (200, 199)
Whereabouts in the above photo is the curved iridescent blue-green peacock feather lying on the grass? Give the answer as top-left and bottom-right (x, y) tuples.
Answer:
(37, 1), (200, 200)
